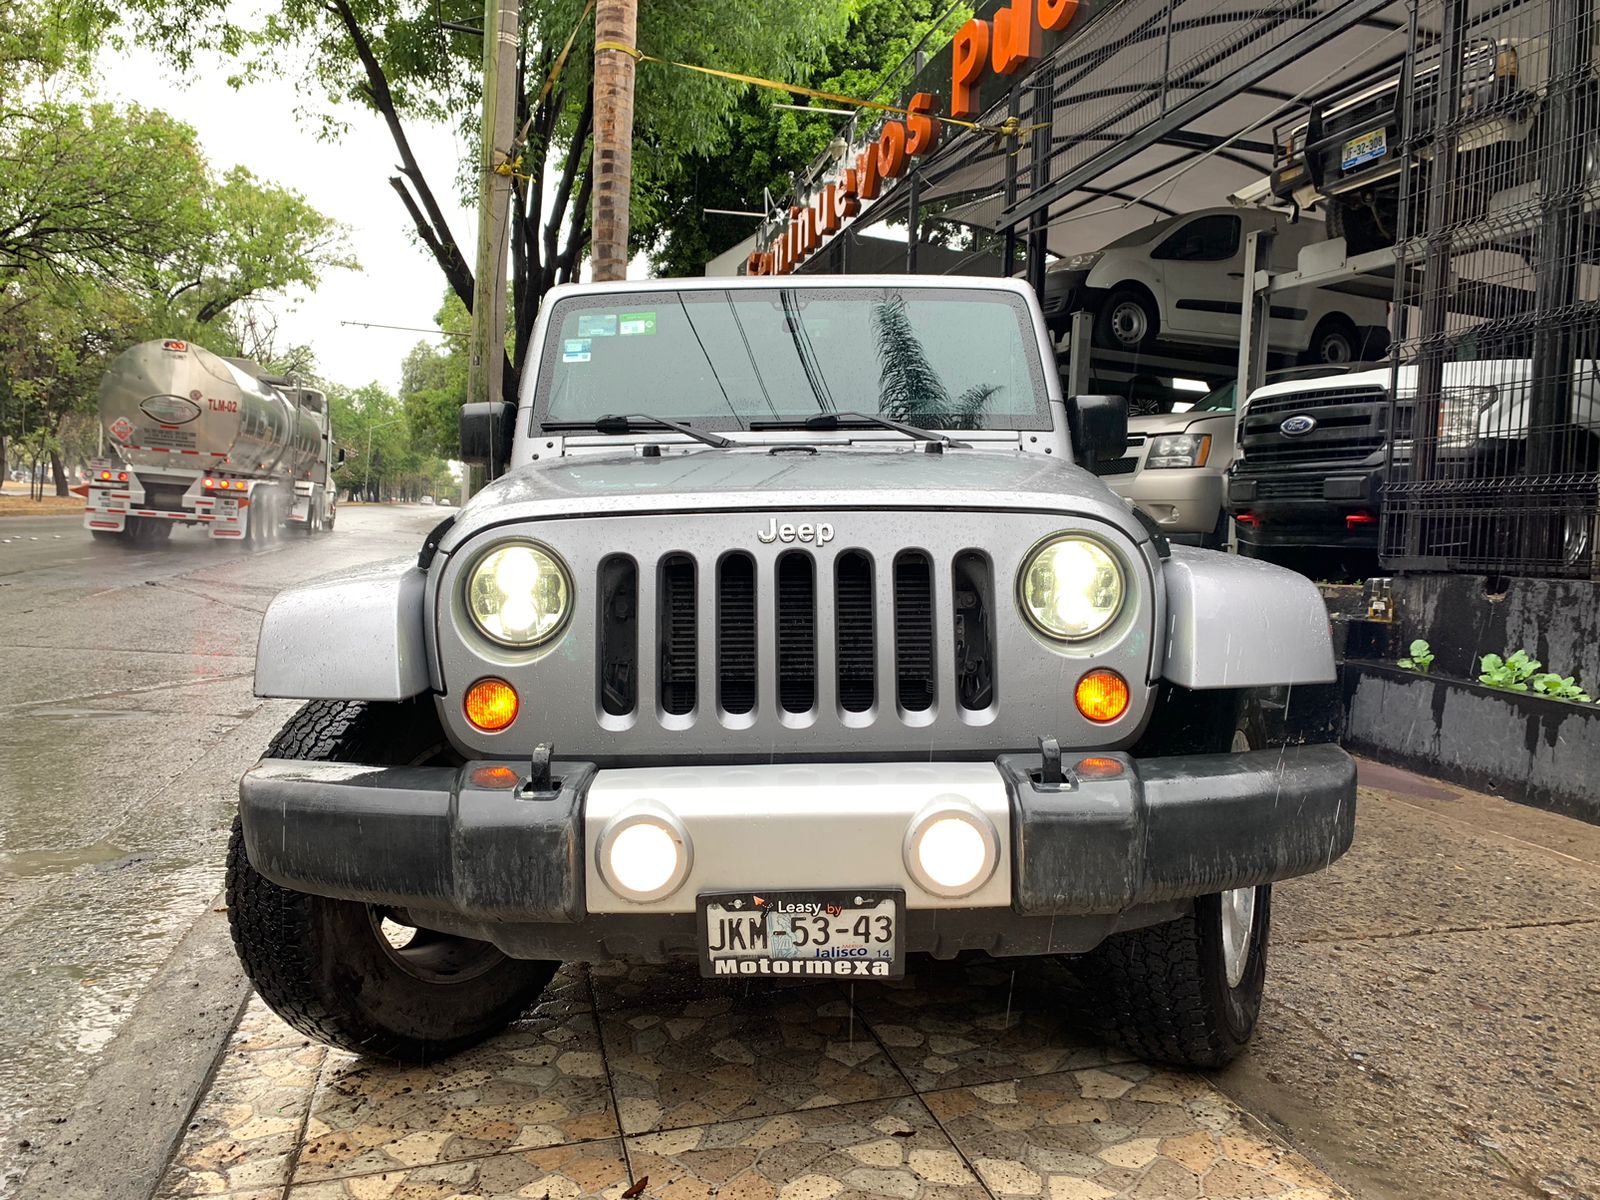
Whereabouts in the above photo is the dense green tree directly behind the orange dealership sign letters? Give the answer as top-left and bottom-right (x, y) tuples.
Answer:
(635, 0), (971, 275)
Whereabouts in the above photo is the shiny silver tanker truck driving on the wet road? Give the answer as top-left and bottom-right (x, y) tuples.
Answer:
(83, 339), (344, 544)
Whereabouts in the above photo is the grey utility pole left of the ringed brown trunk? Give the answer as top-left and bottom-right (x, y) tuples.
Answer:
(467, 0), (522, 470)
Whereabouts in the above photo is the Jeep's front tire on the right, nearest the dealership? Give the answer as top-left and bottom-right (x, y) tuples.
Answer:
(1078, 688), (1272, 1069)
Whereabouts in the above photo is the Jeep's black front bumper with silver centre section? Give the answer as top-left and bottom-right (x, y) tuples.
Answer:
(240, 746), (1355, 958)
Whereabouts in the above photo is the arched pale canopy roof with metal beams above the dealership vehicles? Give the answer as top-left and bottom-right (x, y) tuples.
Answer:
(825, 0), (1518, 265)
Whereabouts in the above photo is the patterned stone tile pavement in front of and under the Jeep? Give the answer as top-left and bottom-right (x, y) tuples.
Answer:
(160, 963), (1346, 1200)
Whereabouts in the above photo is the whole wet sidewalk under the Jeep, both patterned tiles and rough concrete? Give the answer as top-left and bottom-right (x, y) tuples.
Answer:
(147, 765), (1600, 1200)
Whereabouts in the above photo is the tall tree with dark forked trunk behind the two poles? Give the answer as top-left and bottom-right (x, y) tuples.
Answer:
(126, 0), (859, 404)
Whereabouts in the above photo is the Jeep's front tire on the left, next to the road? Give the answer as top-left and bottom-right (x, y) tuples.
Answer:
(227, 698), (558, 1062)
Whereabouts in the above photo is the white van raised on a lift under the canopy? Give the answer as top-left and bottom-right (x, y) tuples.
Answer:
(1045, 208), (1389, 363)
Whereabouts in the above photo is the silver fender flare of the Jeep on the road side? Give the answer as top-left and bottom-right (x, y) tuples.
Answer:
(256, 558), (429, 701)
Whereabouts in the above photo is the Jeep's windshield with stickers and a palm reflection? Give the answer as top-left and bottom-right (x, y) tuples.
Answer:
(533, 286), (1051, 430)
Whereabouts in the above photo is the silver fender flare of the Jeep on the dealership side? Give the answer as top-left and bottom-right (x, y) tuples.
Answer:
(1160, 546), (1338, 690)
